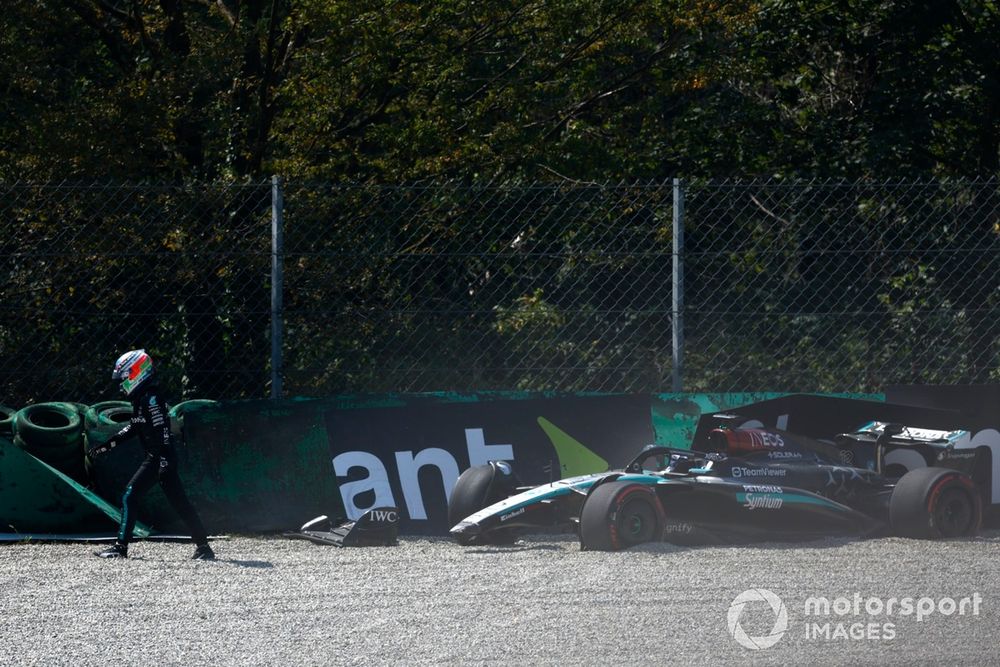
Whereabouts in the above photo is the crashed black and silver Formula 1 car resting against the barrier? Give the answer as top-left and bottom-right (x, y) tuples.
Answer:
(448, 423), (988, 551)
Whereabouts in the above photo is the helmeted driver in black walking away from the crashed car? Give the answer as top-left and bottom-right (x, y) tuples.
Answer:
(90, 350), (215, 560)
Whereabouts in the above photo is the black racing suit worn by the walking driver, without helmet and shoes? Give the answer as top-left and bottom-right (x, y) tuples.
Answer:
(100, 385), (208, 546)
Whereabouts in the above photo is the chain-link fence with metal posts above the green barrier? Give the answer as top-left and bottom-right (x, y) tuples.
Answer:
(0, 179), (1000, 405)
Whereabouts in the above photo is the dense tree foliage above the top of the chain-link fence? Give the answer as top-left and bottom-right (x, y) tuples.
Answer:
(0, 0), (1000, 182)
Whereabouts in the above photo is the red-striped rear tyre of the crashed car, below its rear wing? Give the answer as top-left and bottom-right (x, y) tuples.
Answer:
(889, 468), (983, 539)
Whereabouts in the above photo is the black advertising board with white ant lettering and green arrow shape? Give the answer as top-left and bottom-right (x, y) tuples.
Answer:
(326, 395), (653, 534)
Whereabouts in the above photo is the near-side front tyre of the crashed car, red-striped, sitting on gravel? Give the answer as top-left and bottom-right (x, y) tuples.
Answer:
(580, 482), (664, 551)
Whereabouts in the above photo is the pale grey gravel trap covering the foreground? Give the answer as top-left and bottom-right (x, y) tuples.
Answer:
(0, 531), (1000, 667)
